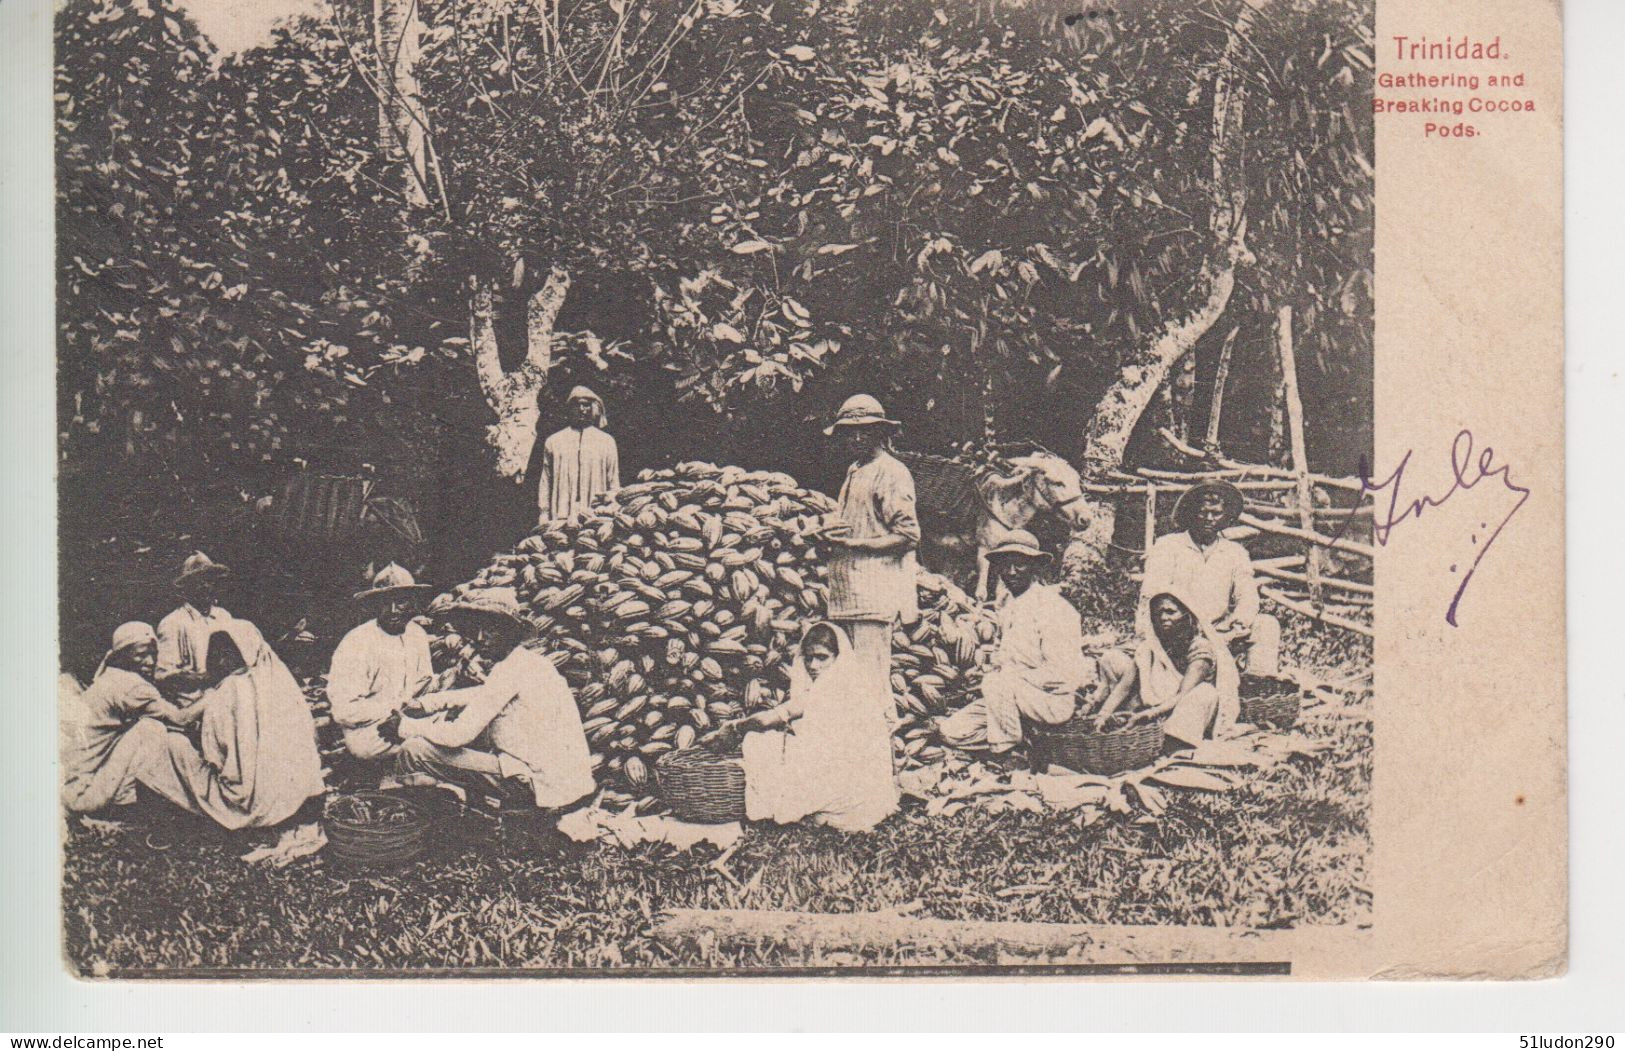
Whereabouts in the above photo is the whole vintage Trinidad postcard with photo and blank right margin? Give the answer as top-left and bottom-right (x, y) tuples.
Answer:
(54, 0), (1567, 980)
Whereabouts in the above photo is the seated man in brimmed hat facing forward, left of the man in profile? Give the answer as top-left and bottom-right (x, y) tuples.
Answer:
(327, 562), (434, 759)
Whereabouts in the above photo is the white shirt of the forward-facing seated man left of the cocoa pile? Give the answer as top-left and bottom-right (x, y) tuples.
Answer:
(327, 621), (434, 757)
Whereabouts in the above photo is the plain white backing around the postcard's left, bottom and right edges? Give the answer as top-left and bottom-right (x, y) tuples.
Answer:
(0, 0), (1625, 1026)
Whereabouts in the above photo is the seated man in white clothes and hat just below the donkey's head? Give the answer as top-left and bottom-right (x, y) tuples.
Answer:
(938, 530), (1095, 754)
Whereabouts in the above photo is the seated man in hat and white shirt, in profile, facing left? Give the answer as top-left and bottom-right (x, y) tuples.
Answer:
(384, 588), (595, 809)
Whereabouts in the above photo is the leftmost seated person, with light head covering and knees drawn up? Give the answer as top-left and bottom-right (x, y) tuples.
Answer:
(62, 621), (191, 814)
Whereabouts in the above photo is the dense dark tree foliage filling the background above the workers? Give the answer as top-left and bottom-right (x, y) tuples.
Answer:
(57, 0), (1372, 662)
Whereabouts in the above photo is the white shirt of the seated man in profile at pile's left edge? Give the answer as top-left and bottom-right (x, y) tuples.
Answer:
(400, 647), (595, 807)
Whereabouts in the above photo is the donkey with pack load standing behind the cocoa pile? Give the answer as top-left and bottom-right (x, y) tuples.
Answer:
(899, 448), (1090, 599)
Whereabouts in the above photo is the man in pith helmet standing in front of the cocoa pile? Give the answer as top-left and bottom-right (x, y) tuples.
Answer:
(821, 395), (920, 740)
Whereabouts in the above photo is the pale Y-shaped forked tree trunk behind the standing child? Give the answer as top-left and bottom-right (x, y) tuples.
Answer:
(468, 266), (570, 482)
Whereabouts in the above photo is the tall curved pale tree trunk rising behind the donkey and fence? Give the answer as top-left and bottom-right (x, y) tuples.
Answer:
(1073, 0), (1268, 562)
